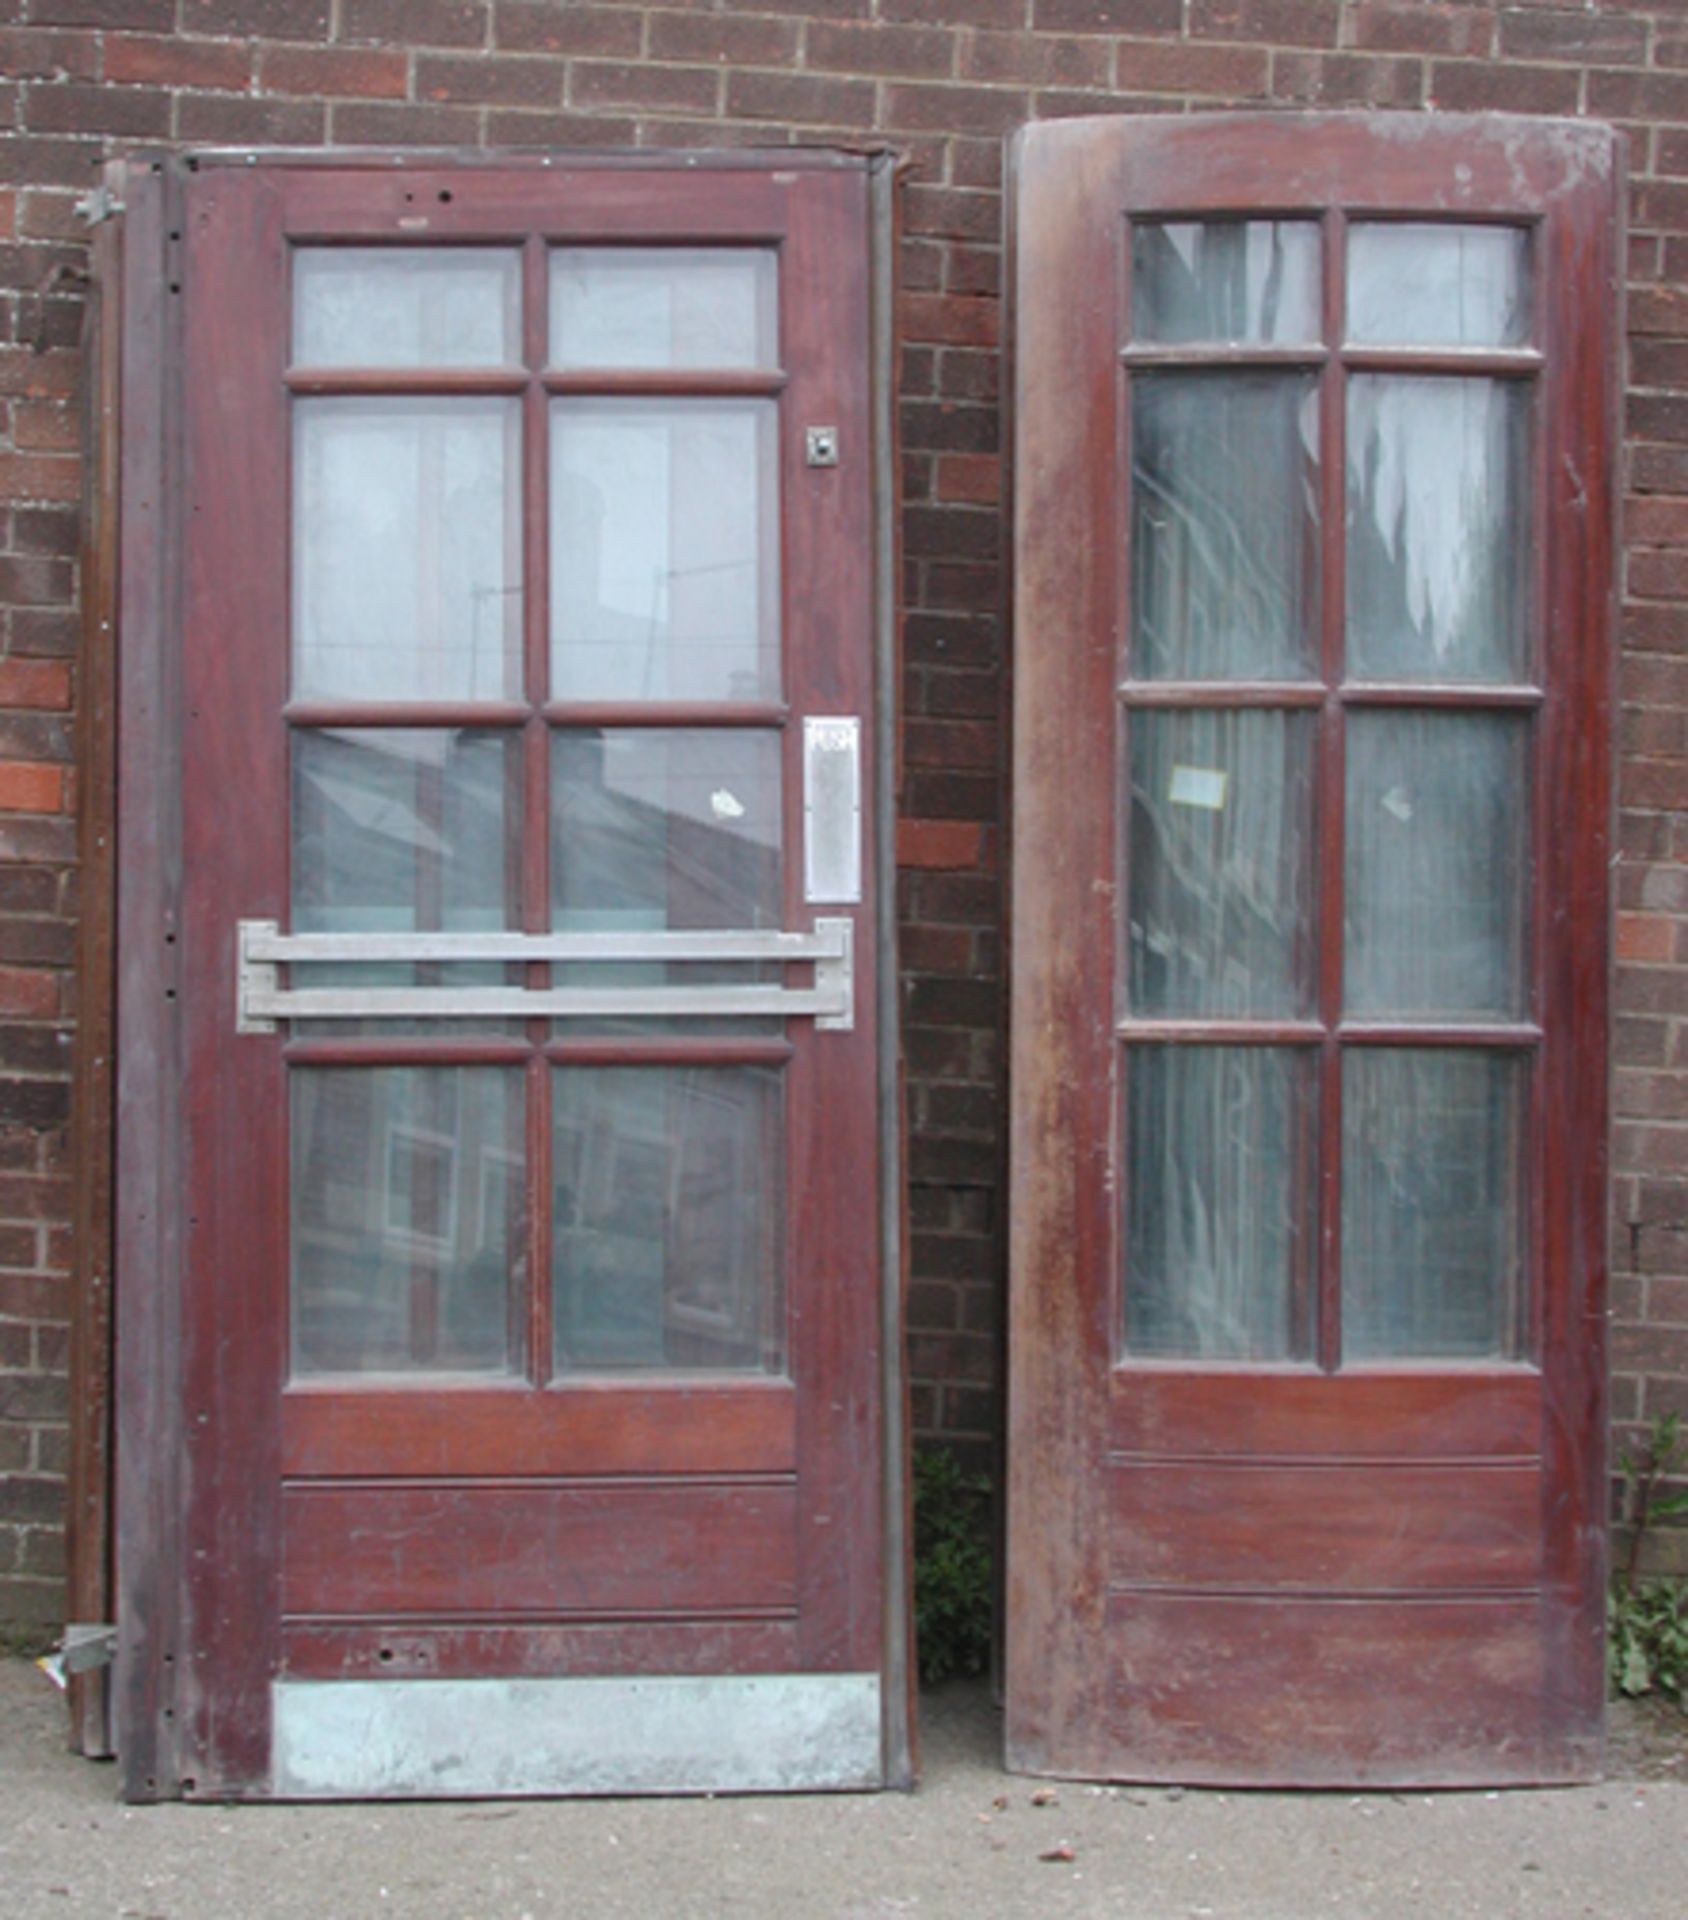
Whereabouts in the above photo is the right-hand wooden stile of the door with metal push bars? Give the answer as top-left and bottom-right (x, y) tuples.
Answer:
(780, 175), (883, 1672)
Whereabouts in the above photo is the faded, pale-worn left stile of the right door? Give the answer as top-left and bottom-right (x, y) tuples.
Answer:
(1004, 129), (1121, 1772)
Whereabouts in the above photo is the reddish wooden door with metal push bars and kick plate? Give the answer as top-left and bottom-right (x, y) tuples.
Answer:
(119, 156), (906, 1797)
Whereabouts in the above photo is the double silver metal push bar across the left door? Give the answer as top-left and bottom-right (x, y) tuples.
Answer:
(234, 918), (855, 1033)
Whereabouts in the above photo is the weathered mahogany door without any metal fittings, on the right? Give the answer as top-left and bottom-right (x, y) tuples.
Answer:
(1006, 115), (1621, 1786)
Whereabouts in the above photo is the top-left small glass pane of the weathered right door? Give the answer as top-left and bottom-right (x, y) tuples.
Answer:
(1131, 221), (1321, 346)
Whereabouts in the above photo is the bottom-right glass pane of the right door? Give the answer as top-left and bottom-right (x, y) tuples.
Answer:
(1342, 1046), (1527, 1361)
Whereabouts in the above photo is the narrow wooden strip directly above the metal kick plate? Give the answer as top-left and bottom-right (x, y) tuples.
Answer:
(282, 1619), (797, 1680)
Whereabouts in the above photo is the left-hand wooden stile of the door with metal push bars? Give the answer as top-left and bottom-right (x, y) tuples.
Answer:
(181, 161), (290, 1797)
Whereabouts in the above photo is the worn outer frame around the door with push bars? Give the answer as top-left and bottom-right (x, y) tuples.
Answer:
(98, 150), (916, 1801)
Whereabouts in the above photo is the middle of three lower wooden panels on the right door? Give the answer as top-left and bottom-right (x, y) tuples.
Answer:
(1110, 1461), (1542, 1592)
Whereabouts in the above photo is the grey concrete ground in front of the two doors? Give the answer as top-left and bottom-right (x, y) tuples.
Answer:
(0, 1659), (1688, 1920)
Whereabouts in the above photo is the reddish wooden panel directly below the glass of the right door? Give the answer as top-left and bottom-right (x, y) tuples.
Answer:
(1110, 1367), (1542, 1459)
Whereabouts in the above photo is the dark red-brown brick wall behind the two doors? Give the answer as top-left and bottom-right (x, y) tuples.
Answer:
(0, 0), (1688, 1620)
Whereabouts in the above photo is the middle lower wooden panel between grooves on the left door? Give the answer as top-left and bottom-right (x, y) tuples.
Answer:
(282, 1480), (797, 1617)
